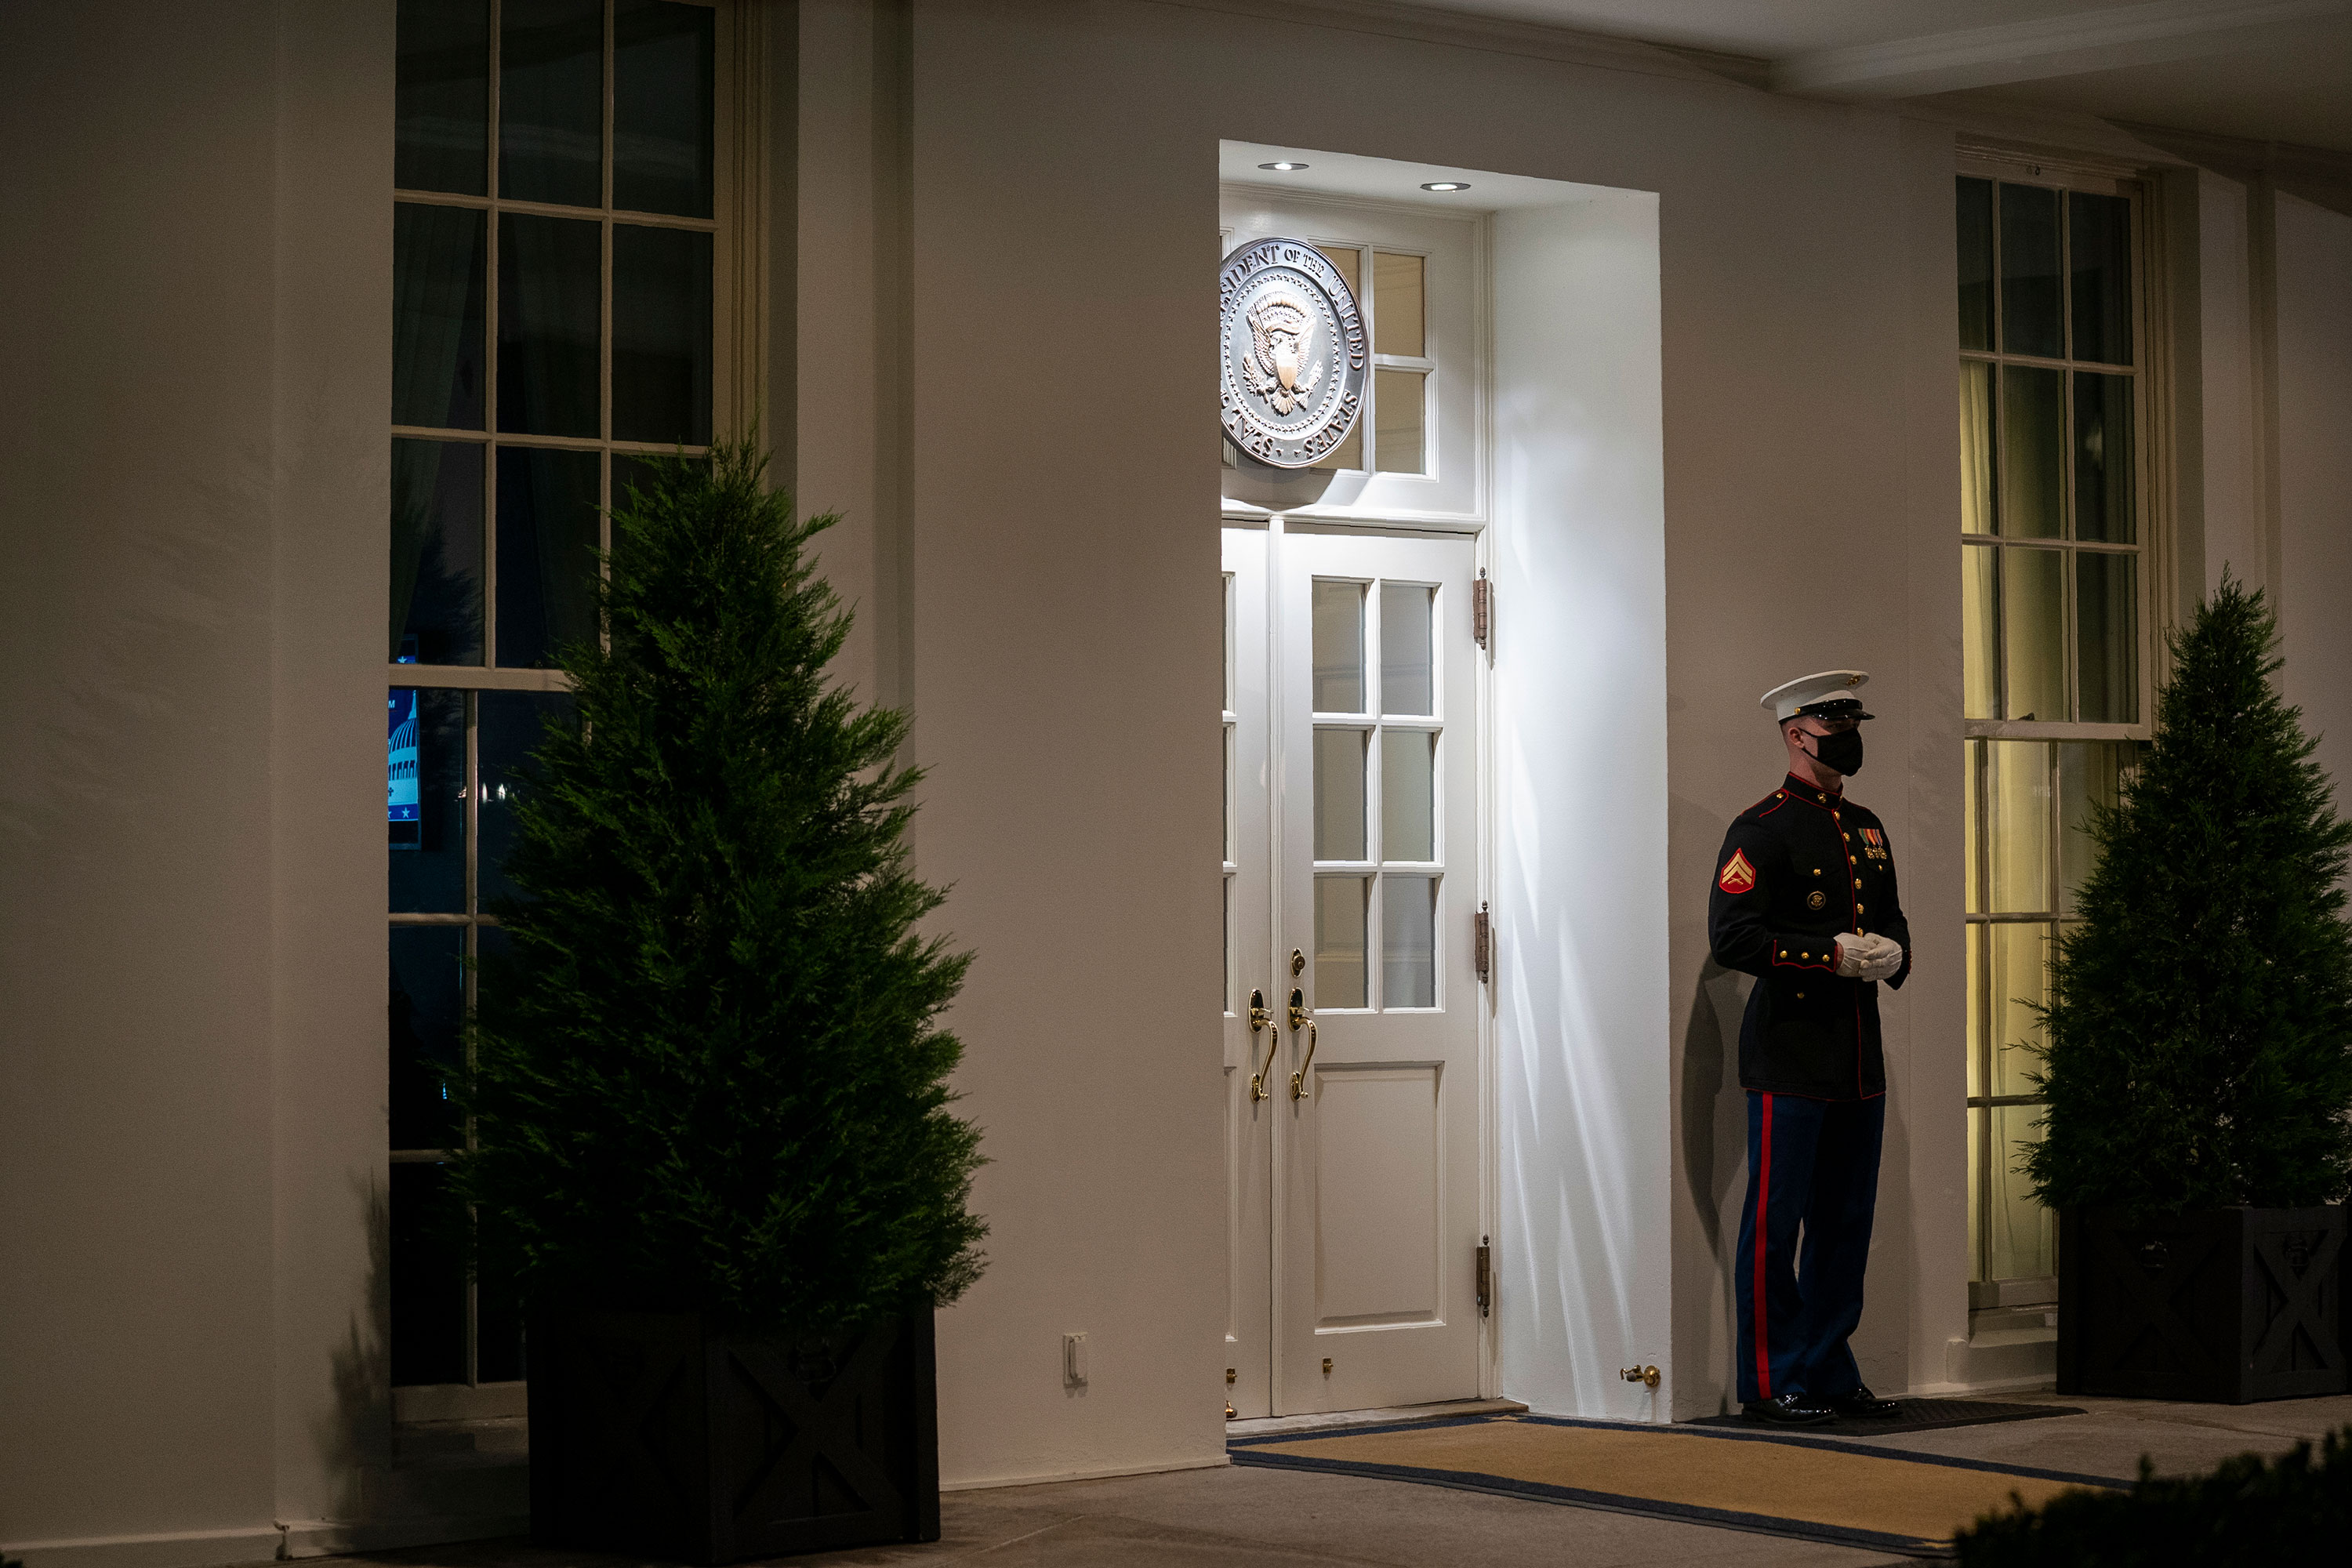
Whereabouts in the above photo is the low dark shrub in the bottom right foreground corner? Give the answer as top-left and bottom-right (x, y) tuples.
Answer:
(1955, 1427), (2352, 1568)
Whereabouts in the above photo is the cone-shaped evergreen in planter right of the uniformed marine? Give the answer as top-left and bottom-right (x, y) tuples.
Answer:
(2027, 576), (2352, 1215)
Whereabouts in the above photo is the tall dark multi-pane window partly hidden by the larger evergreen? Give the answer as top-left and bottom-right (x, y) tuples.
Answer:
(386, 0), (720, 1415)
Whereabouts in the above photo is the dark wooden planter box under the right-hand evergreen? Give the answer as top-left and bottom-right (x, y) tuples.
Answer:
(2058, 1203), (2352, 1403)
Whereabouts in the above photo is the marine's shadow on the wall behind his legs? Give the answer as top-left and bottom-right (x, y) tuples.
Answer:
(1682, 954), (1755, 1408)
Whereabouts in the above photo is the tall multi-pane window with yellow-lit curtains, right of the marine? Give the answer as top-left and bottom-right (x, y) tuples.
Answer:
(1957, 169), (2150, 1312)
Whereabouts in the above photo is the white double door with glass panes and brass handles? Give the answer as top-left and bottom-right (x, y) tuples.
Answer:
(1225, 522), (1486, 1417)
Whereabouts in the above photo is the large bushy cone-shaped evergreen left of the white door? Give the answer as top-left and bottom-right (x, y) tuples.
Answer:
(452, 445), (985, 1333)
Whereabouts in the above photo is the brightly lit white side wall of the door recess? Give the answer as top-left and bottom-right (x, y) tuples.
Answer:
(1491, 193), (1675, 1420)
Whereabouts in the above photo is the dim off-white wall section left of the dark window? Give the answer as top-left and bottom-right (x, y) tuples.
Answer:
(0, 2), (393, 1568)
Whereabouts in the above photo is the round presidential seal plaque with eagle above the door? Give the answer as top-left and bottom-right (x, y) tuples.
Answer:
(1216, 240), (1371, 468)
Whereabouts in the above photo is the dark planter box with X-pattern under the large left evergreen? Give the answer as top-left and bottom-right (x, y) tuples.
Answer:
(532, 1312), (938, 1563)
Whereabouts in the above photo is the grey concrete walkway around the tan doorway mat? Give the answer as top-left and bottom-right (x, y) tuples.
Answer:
(374, 1394), (2352, 1568)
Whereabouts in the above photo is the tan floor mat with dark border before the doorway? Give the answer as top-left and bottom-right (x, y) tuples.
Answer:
(1228, 1415), (2131, 1556)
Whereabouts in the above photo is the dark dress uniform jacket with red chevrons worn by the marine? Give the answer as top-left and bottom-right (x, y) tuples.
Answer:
(1708, 774), (1910, 1100)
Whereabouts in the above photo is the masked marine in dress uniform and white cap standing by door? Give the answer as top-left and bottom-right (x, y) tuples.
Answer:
(1708, 670), (1910, 1425)
